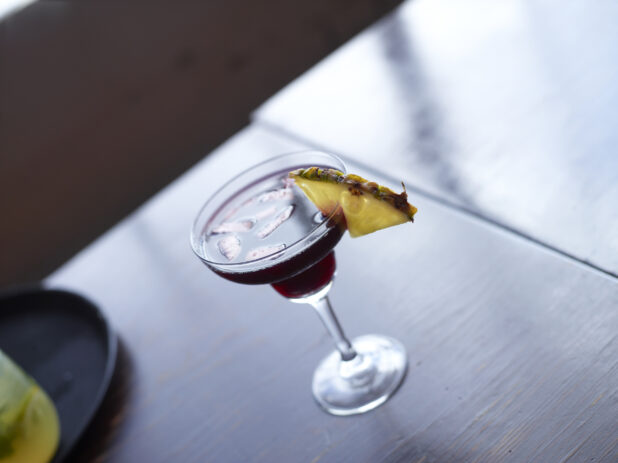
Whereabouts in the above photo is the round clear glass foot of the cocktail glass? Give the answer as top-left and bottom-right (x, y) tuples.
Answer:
(313, 334), (408, 416)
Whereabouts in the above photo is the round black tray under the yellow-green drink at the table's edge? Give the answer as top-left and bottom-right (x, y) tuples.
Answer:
(0, 288), (117, 463)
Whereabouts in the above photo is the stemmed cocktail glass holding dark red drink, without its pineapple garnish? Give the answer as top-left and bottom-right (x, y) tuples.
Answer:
(191, 151), (407, 415)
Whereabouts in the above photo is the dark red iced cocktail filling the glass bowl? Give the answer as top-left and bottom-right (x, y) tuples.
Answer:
(195, 163), (345, 298)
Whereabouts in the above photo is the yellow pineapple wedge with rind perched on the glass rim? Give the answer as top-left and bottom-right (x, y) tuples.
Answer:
(289, 167), (417, 237)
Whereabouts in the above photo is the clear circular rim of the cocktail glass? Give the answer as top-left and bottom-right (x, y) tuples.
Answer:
(190, 149), (346, 273)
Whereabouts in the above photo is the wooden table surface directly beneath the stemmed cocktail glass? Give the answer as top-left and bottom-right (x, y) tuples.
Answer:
(47, 125), (618, 463)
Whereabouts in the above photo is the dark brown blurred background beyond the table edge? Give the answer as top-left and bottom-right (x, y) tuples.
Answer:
(0, 0), (399, 286)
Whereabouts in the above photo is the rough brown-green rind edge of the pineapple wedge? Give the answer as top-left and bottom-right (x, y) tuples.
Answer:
(288, 167), (417, 222)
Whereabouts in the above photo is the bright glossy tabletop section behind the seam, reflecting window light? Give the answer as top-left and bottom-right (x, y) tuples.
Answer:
(255, 0), (618, 276)
